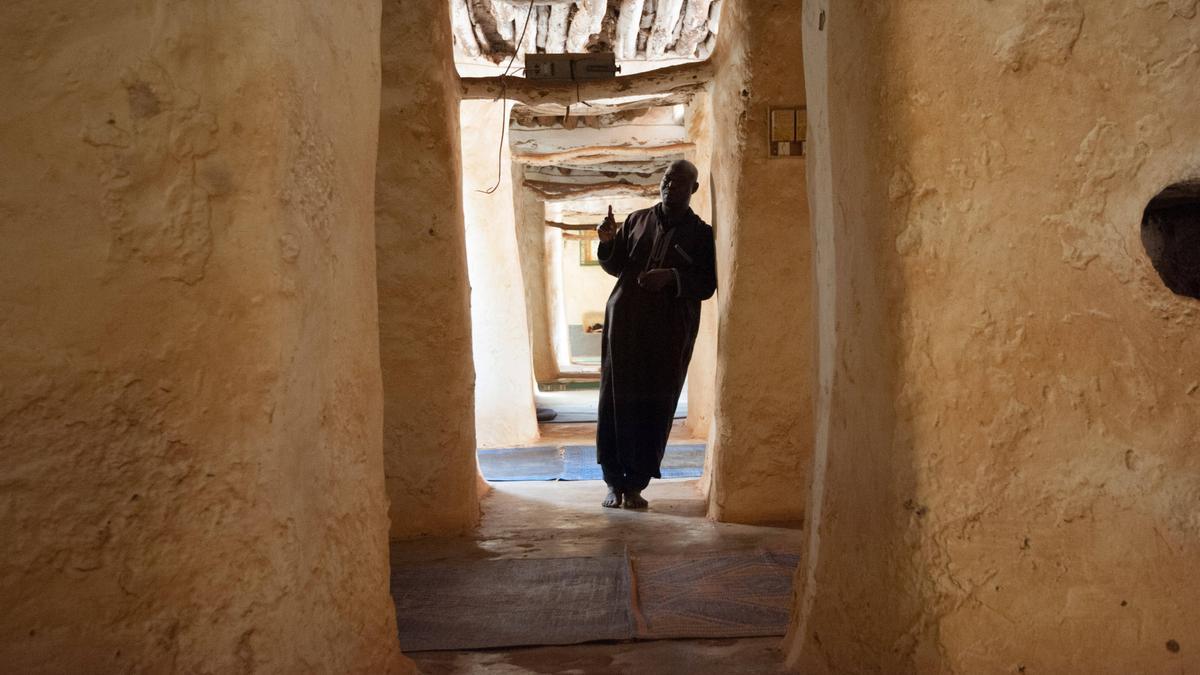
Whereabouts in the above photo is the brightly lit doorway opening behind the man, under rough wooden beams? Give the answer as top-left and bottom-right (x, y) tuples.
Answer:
(455, 1), (719, 480)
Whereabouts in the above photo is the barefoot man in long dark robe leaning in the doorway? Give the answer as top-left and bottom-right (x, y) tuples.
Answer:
(596, 160), (716, 508)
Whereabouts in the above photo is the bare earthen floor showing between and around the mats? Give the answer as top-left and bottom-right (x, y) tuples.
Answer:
(391, 424), (800, 675)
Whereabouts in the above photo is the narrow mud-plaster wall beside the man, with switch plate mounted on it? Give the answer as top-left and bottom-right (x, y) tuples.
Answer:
(709, 0), (814, 522)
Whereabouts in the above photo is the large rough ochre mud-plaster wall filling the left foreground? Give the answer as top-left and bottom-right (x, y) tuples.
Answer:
(0, 0), (402, 673)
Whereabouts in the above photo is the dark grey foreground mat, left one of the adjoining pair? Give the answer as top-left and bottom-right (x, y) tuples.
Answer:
(391, 556), (634, 652)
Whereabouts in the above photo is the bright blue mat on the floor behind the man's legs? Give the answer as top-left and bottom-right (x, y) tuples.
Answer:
(478, 444), (704, 482)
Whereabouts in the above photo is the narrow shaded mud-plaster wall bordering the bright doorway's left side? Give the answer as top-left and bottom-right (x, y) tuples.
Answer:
(376, 0), (479, 537)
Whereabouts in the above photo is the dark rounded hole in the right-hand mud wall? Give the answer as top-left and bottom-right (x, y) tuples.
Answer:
(1141, 178), (1200, 299)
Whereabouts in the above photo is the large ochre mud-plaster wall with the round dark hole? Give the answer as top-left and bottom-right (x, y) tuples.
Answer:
(790, 0), (1200, 673)
